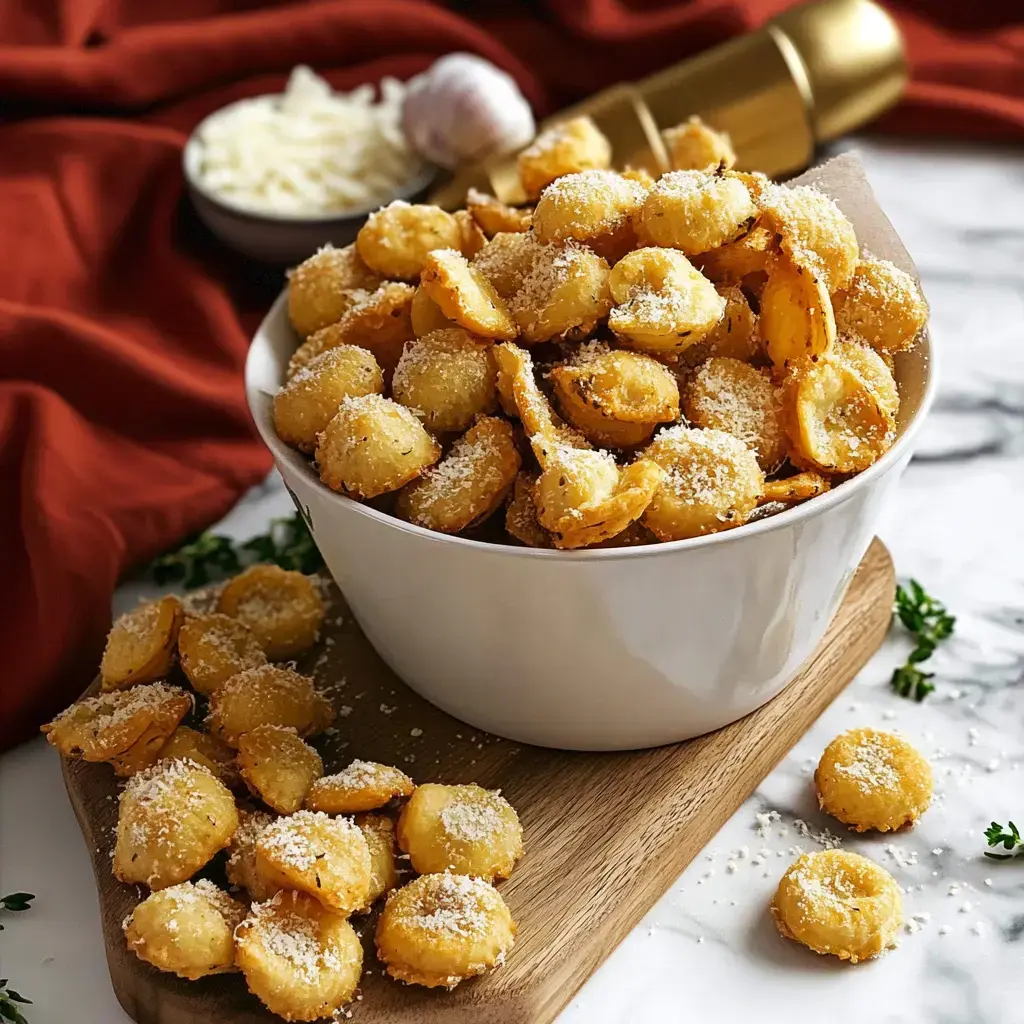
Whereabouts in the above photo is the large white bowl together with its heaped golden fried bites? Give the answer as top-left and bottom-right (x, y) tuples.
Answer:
(247, 118), (934, 750)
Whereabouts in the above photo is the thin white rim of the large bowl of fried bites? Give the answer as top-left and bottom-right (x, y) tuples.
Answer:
(245, 288), (938, 564)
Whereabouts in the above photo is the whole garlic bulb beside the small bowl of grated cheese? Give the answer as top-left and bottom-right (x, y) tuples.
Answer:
(401, 53), (535, 168)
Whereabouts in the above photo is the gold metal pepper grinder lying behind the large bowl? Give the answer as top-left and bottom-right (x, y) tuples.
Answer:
(431, 0), (907, 207)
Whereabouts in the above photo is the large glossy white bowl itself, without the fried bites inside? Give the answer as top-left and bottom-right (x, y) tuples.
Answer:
(246, 295), (935, 751)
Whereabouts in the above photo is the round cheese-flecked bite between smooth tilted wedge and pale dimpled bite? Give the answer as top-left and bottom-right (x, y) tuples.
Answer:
(509, 242), (611, 344)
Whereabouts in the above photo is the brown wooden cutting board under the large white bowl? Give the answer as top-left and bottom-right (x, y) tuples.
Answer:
(63, 541), (895, 1024)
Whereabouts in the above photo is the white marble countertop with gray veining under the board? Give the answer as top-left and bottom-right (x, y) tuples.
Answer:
(0, 144), (1024, 1024)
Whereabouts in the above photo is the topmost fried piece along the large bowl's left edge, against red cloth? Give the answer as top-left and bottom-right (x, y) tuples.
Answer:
(288, 245), (381, 338)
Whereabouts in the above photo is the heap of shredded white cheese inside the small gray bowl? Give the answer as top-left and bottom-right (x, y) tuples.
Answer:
(196, 67), (423, 215)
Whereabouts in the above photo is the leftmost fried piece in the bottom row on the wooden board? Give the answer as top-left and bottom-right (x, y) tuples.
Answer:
(123, 879), (247, 981)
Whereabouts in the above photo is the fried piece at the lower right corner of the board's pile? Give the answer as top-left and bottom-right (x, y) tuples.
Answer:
(377, 871), (516, 989)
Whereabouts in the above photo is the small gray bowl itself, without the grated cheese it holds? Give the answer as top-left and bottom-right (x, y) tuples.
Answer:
(181, 100), (437, 265)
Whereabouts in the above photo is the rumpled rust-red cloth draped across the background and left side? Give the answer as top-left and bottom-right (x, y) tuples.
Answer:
(0, 0), (1024, 749)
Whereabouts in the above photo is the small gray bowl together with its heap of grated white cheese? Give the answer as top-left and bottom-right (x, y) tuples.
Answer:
(182, 67), (437, 263)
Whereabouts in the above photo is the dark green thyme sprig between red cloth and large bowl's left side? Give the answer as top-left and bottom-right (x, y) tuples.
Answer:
(146, 512), (324, 587)
